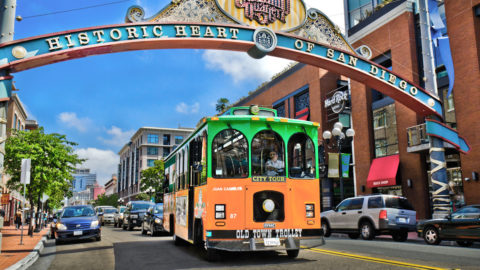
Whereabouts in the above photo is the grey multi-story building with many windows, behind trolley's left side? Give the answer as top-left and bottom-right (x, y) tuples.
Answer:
(117, 127), (193, 202)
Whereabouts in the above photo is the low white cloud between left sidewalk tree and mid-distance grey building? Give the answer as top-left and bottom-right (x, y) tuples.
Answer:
(75, 147), (120, 185)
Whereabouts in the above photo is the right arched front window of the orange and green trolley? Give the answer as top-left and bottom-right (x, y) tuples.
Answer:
(288, 133), (316, 179)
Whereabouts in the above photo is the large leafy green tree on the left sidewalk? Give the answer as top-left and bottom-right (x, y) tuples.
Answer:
(4, 127), (84, 230)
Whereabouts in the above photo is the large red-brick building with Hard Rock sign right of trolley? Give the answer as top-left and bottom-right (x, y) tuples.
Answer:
(236, 0), (480, 218)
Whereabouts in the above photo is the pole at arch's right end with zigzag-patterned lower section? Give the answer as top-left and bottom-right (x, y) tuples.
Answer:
(418, 0), (451, 218)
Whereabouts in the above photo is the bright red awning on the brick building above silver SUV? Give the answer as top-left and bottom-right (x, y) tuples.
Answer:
(367, 155), (400, 188)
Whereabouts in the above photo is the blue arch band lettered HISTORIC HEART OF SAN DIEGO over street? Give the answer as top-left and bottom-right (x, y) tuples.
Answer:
(0, 23), (443, 118)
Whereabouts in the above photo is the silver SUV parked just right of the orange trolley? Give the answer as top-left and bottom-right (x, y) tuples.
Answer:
(320, 194), (417, 241)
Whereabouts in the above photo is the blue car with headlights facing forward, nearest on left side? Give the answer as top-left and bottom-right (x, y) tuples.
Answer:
(55, 205), (101, 244)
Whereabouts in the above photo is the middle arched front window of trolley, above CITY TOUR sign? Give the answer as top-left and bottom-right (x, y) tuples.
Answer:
(252, 130), (285, 176)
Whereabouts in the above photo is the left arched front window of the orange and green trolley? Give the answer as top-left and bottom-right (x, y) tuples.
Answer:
(212, 129), (248, 178)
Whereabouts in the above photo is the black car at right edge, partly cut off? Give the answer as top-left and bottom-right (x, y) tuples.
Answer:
(417, 204), (480, 247)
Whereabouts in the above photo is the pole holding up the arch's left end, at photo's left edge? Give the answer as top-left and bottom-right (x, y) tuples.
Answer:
(0, 0), (17, 184)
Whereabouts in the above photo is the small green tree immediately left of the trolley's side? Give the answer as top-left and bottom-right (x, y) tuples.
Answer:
(137, 160), (165, 201)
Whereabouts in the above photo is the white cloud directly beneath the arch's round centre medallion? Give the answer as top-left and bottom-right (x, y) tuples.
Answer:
(203, 50), (291, 83)
